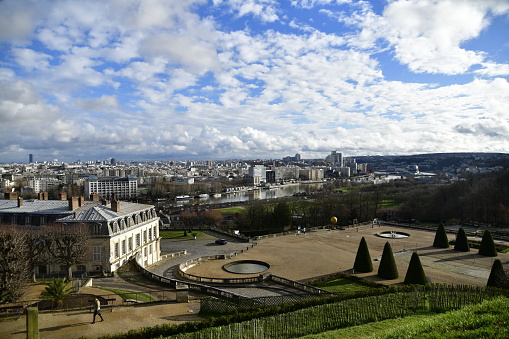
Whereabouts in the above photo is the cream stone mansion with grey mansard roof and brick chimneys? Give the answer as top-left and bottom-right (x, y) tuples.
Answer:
(0, 193), (161, 274)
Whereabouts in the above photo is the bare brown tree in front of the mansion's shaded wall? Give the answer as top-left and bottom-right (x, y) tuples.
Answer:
(45, 223), (91, 279)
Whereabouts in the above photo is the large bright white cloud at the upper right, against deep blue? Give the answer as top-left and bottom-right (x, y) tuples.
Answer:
(354, 0), (509, 74)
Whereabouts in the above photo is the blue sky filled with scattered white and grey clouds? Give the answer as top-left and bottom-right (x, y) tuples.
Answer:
(0, 0), (509, 162)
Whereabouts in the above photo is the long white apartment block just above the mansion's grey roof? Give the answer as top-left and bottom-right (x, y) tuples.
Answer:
(84, 175), (138, 199)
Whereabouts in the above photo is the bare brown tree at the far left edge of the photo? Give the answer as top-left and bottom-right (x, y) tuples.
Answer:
(0, 225), (28, 303)
